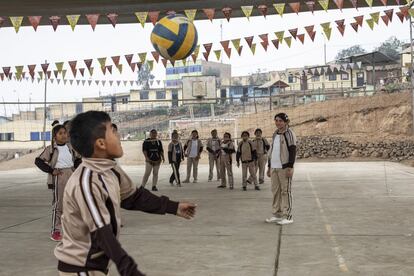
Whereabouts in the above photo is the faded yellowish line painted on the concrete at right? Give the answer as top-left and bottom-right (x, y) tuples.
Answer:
(306, 173), (348, 272)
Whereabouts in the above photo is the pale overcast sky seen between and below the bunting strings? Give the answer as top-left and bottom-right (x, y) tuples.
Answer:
(0, 7), (409, 113)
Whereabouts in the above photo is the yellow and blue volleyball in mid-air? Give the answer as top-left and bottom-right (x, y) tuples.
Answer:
(151, 14), (198, 60)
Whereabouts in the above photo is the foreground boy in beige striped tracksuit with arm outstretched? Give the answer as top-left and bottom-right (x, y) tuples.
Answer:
(55, 111), (196, 276)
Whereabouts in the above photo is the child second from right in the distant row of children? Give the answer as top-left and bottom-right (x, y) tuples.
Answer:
(236, 131), (260, 191)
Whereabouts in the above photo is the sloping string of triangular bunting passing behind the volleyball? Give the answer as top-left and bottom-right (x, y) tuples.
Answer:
(0, 6), (414, 81)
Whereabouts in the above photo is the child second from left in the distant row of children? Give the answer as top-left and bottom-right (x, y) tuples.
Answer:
(168, 131), (184, 187)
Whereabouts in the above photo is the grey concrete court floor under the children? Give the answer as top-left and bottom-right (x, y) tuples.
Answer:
(0, 162), (414, 276)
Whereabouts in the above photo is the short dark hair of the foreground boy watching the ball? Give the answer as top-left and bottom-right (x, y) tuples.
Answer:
(70, 111), (111, 157)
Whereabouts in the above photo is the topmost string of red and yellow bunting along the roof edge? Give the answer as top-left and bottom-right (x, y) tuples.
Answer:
(0, 0), (412, 33)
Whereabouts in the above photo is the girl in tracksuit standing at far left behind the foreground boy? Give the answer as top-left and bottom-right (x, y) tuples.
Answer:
(35, 124), (81, 241)
